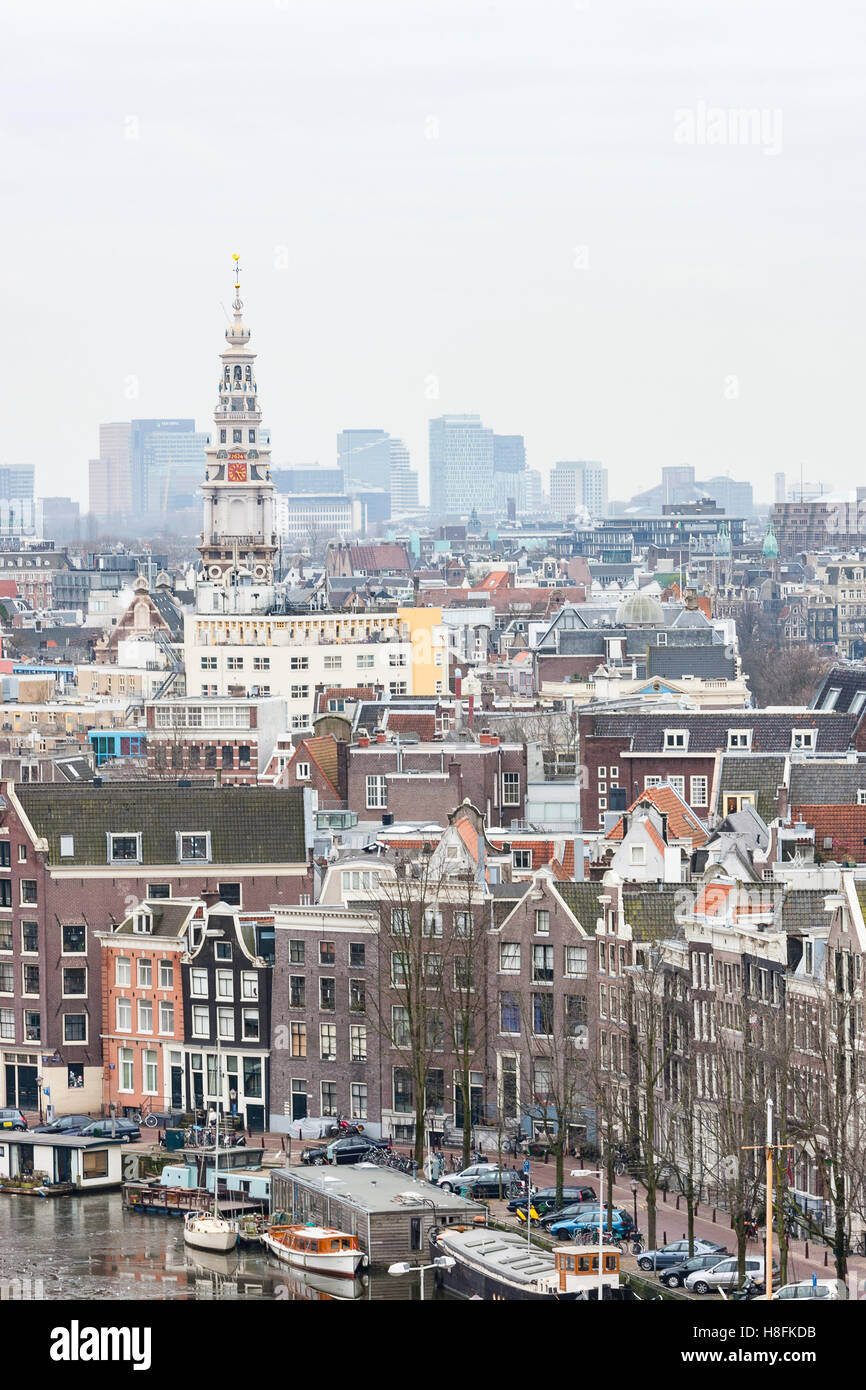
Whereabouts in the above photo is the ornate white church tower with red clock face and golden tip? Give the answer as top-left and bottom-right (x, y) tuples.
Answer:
(197, 256), (277, 612)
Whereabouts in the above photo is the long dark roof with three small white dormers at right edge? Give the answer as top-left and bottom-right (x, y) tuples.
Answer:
(592, 710), (859, 753)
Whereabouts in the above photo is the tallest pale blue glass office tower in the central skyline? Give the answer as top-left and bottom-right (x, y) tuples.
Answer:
(430, 416), (493, 518)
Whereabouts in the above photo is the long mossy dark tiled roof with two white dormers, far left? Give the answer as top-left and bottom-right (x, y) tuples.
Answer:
(15, 783), (306, 873)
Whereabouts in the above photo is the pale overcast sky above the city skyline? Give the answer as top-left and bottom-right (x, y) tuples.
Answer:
(0, 0), (866, 505)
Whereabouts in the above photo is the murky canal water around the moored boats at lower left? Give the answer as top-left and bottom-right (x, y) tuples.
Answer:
(0, 1193), (445, 1301)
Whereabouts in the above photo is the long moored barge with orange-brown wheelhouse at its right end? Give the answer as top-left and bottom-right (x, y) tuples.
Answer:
(430, 1229), (637, 1301)
